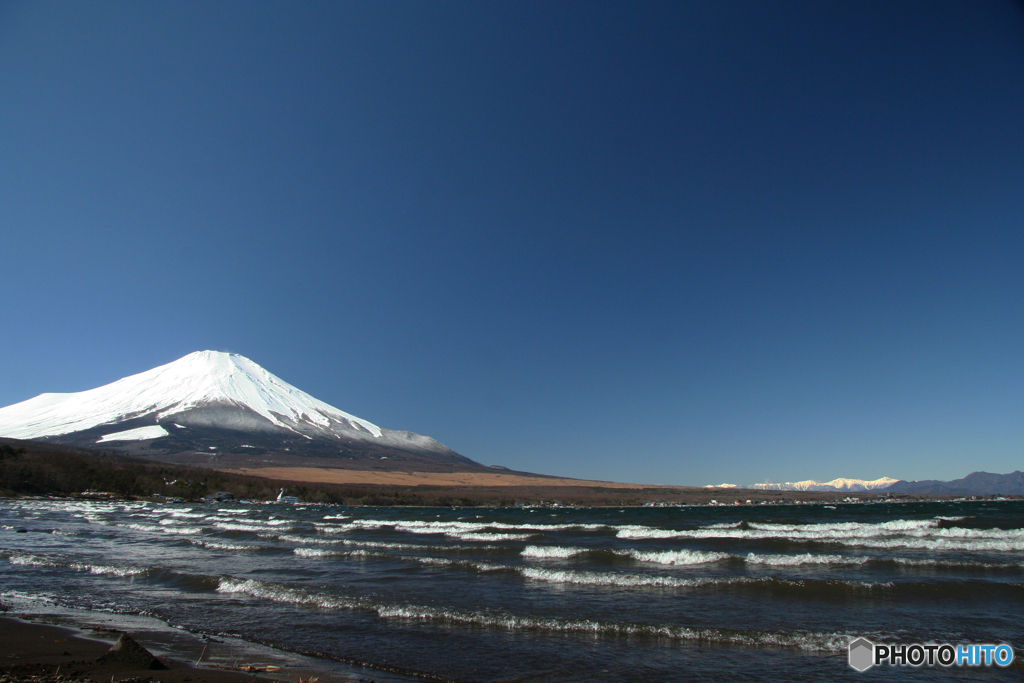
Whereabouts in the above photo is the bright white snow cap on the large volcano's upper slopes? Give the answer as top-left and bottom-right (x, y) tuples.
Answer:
(0, 351), (382, 439)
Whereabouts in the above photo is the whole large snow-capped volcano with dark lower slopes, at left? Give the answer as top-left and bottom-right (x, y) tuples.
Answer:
(0, 351), (486, 471)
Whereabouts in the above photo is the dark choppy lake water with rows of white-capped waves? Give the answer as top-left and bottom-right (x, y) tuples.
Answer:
(0, 500), (1024, 682)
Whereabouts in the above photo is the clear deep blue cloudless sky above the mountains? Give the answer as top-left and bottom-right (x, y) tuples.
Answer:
(0, 0), (1024, 484)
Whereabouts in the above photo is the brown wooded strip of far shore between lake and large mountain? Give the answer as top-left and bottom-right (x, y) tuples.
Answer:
(0, 439), (983, 507)
